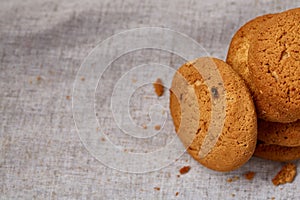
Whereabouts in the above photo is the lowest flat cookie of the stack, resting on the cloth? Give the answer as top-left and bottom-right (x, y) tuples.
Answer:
(254, 144), (300, 162)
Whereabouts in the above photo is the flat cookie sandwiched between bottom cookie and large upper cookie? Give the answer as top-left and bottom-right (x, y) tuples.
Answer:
(257, 119), (300, 147)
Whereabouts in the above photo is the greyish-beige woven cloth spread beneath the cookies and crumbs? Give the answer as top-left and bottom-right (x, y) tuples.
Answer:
(0, 0), (300, 199)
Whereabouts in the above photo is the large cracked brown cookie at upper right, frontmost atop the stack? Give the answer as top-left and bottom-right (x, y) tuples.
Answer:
(248, 8), (300, 123)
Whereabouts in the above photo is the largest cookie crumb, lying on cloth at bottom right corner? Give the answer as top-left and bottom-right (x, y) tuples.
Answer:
(272, 163), (297, 186)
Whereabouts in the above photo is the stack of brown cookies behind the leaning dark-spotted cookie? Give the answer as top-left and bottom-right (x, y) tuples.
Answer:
(226, 8), (300, 161)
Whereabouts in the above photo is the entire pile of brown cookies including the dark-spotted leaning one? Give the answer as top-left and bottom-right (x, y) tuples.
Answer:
(170, 8), (300, 171)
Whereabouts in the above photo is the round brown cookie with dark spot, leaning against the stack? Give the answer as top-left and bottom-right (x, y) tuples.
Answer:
(170, 58), (257, 171)
